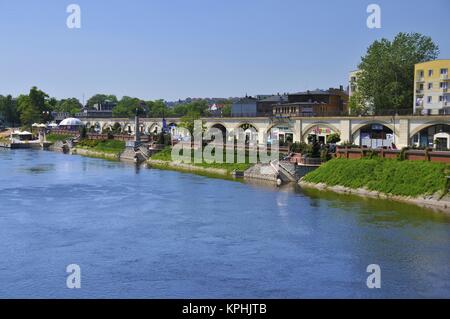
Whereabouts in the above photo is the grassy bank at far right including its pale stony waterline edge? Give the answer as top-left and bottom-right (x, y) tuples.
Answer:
(299, 158), (450, 211)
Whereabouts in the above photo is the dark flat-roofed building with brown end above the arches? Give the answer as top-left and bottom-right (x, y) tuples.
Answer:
(273, 86), (348, 116)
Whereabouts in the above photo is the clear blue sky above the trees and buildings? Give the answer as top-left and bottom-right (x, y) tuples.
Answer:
(0, 0), (450, 100)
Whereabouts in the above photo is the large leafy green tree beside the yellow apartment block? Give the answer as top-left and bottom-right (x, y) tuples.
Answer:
(357, 33), (439, 113)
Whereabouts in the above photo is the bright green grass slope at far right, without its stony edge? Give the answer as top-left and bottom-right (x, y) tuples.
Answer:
(303, 158), (450, 197)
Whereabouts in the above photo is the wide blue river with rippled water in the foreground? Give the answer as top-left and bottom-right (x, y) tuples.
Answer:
(0, 149), (450, 298)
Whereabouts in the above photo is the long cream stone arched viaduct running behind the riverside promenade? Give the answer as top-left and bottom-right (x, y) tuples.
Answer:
(82, 115), (450, 147)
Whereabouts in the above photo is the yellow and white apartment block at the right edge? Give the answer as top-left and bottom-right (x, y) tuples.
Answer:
(414, 60), (450, 114)
